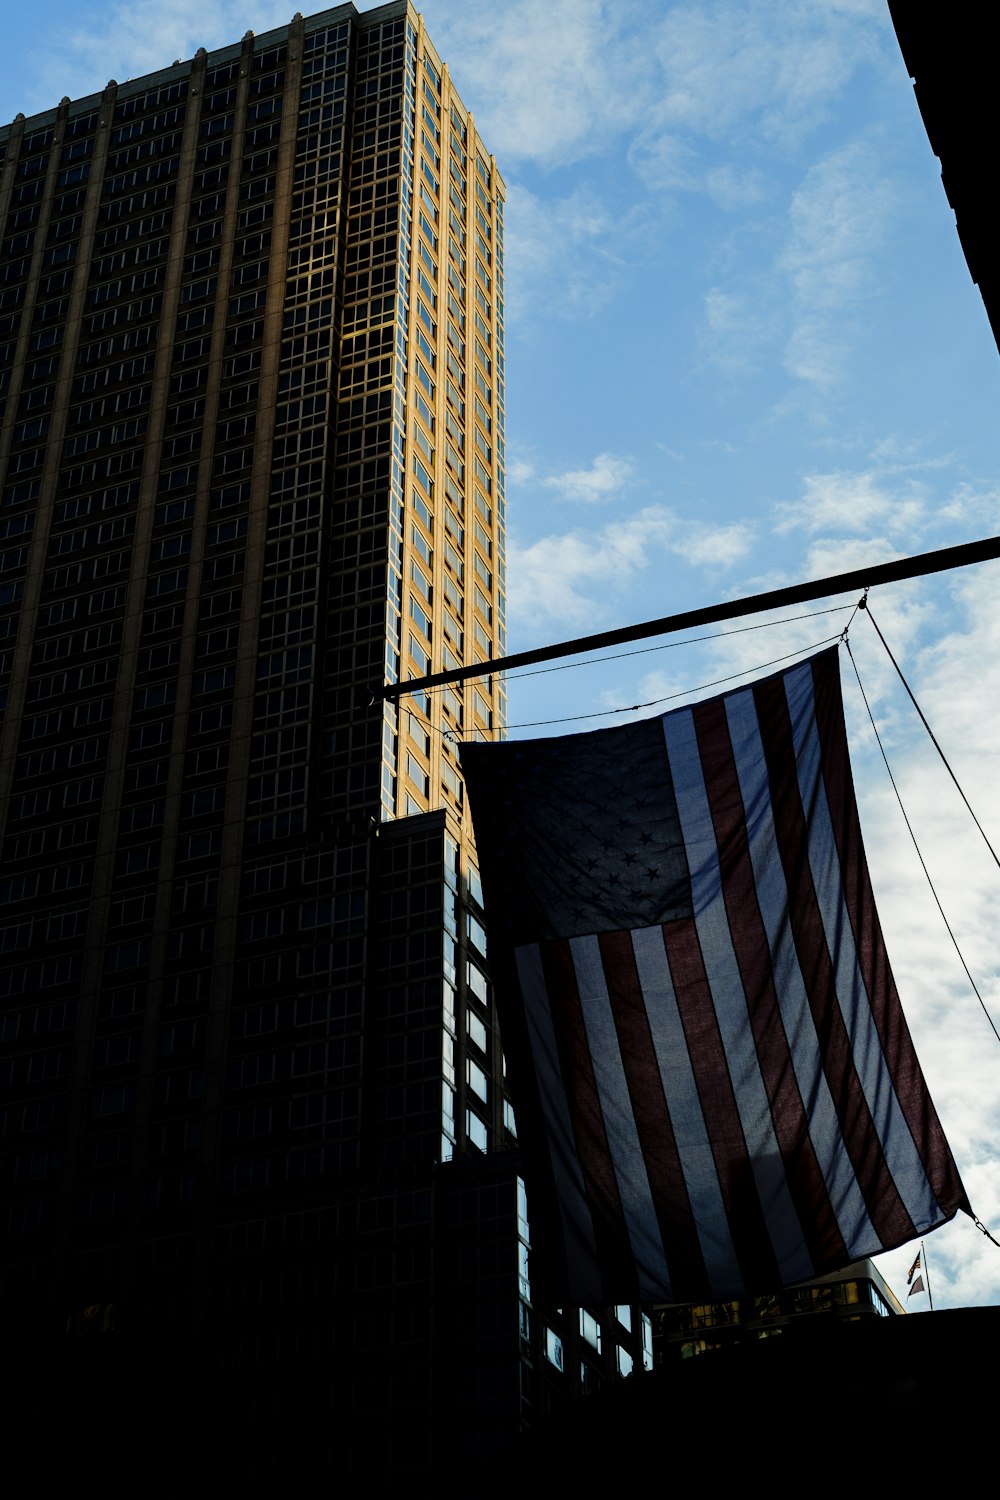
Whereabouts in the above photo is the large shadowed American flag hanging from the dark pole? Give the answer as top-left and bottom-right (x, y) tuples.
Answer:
(462, 648), (970, 1304)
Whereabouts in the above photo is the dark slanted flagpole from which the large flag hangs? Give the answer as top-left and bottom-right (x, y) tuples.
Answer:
(376, 537), (1000, 702)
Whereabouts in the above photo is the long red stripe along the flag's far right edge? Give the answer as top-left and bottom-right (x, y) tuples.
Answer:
(813, 656), (972, 1218)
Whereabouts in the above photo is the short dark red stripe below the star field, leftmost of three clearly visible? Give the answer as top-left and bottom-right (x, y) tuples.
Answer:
(540, 939), (639, 1302)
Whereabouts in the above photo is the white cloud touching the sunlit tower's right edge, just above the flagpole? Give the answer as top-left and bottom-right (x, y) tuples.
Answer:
(508, 506), (751, 629)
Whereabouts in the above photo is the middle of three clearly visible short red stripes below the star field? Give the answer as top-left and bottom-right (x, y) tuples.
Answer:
(598, 933), (708, 1302)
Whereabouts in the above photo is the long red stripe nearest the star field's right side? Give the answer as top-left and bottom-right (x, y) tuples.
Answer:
(694, 698), (850, 1275)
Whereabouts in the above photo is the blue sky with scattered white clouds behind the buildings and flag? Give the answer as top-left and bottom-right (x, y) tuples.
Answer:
(0, 0), (1000, 1311)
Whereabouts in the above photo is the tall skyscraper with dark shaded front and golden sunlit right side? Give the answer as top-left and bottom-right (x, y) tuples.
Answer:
(0, 0), (653, 1470)
